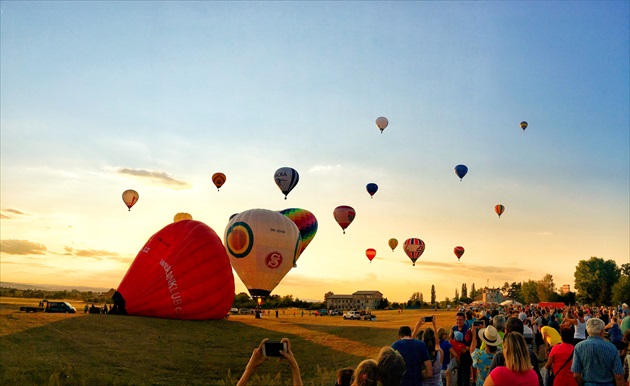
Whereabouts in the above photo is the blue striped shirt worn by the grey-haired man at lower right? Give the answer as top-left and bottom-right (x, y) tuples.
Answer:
(571, 336), (624, 386)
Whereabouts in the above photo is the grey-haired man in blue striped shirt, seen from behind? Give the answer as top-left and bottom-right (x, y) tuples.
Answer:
(571, 318), (624, 386)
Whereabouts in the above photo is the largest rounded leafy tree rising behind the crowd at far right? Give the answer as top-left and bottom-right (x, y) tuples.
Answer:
(573, 256), (621, 305)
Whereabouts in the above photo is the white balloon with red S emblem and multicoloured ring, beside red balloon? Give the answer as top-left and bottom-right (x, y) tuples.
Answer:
(223, 209), (301, 299)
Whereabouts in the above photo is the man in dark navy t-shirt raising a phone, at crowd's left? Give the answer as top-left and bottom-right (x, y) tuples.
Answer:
(392, 317), (433, 386)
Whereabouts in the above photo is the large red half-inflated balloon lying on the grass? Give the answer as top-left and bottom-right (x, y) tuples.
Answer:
(112, 220), (234, 320)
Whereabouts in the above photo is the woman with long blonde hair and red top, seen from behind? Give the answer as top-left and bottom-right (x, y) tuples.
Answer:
(483, 332), (538, 386)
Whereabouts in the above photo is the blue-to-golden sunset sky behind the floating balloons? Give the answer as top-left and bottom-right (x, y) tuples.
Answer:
(0, 1), (630, 301)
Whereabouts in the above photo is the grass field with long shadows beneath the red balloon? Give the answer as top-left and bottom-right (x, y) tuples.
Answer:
(0, 298), (455, 385)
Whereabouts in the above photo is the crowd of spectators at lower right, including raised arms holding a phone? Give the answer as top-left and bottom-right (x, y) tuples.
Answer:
(238, 303), (630, 386)
